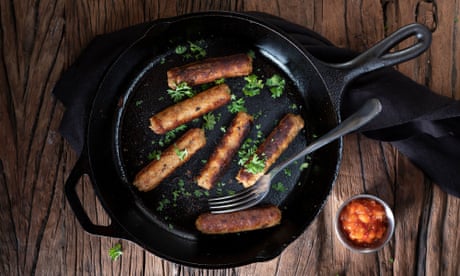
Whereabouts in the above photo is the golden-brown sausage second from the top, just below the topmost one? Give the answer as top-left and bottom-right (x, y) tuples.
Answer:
(150, 84), (231, 134)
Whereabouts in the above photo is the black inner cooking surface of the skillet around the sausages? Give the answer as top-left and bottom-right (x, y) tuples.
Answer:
(115, 35), (314, 239)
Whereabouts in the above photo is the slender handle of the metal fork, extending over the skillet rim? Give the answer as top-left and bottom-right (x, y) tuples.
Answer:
(269, 98), (382, 177)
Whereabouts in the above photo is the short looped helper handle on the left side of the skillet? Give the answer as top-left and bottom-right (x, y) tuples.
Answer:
(65, 154), (129, 240)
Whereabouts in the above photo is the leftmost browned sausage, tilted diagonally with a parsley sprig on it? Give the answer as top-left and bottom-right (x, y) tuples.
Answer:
(133, 128), (206, 192)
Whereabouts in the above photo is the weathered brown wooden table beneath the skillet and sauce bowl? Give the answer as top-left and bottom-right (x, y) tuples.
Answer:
(0, 0), (460, 275)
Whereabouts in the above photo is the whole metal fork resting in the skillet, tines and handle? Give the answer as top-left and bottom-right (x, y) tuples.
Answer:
(208, 99), (382, 214)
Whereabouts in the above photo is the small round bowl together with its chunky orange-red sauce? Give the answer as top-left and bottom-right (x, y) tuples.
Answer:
(336, 195), (394, 253)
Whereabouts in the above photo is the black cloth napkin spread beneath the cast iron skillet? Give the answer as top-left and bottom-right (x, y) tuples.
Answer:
(53, 13), (460, 197)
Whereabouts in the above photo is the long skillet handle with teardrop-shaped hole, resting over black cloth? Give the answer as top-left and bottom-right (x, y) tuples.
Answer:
(329, 23), (431, 82)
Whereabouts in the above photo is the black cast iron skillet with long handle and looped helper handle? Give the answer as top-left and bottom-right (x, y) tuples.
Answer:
(66, 12), (431, 268)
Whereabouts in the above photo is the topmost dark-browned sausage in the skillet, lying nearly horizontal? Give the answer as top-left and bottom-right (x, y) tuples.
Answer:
(167, 54), (252, 89)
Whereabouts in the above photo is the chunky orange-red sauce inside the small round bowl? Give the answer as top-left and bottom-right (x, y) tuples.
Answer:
(339, 198), (388, 247)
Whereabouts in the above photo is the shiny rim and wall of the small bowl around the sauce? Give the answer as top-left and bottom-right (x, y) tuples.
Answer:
(334, 194), (395, 253)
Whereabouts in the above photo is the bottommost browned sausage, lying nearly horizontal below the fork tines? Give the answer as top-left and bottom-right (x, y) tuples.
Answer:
(195, 205), (281, 234)
